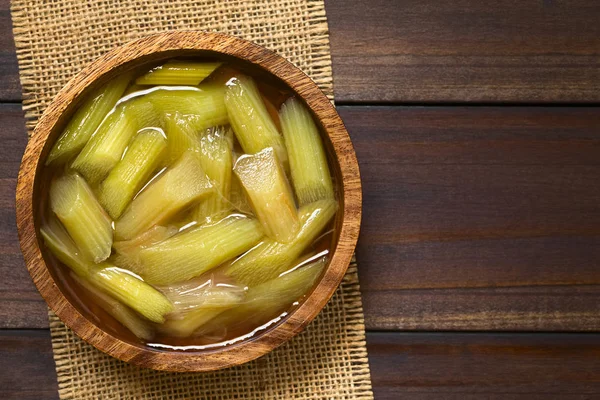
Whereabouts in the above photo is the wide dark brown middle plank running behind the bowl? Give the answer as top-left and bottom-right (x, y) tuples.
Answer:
(5, 106), (600, 331)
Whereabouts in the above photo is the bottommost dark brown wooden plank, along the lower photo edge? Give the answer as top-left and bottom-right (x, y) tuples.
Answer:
(0, 330), (600, 400)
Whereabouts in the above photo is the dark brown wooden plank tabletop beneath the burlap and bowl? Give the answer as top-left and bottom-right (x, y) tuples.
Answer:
(0, 0), (600, 400)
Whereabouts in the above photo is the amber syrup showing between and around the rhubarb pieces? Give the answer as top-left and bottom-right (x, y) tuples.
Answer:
(36, 59), (341, 351)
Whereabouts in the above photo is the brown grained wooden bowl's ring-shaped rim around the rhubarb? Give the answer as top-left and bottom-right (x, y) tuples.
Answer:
(16, 31), (361, 371)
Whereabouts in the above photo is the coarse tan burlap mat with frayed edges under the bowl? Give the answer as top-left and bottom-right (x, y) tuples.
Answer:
(11, 0), (373, 400)
